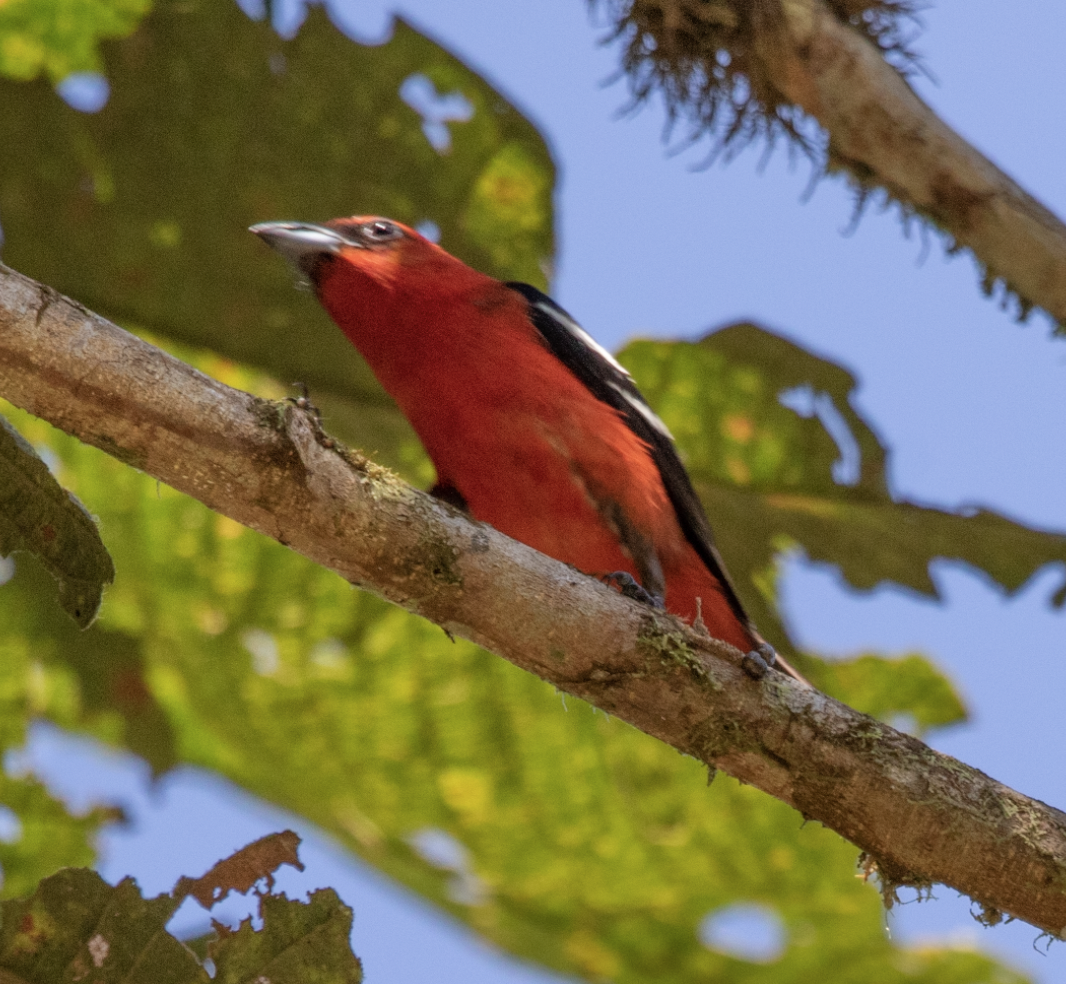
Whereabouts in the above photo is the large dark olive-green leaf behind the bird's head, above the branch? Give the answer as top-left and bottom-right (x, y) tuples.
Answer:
(0, 0), (554, 473)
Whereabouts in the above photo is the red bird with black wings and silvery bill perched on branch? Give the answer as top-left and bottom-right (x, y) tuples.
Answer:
(252, 216), (794, 675)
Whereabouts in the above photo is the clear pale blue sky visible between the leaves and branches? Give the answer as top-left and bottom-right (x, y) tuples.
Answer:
(16, 0), (1066, 984)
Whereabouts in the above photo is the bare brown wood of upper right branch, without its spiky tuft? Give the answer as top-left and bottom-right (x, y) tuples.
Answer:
(774, 0), (1066, 325)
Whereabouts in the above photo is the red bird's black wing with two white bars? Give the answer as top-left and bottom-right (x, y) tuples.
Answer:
(506, 281), (752, 627)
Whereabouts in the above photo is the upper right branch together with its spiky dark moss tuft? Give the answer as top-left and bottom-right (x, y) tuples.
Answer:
(593, 0), (1066, 330)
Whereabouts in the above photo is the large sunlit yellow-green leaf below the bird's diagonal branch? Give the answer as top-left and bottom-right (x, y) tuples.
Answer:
(0, 396), (1022, 984)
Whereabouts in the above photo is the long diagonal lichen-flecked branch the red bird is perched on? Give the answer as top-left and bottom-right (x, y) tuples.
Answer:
(0, 267), (1066, 935)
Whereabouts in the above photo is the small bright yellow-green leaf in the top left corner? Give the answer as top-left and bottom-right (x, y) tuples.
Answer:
(0, 0), (150, 82)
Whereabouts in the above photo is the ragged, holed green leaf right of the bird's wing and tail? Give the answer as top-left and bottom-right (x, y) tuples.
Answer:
(619, 323), (1066, 712)
